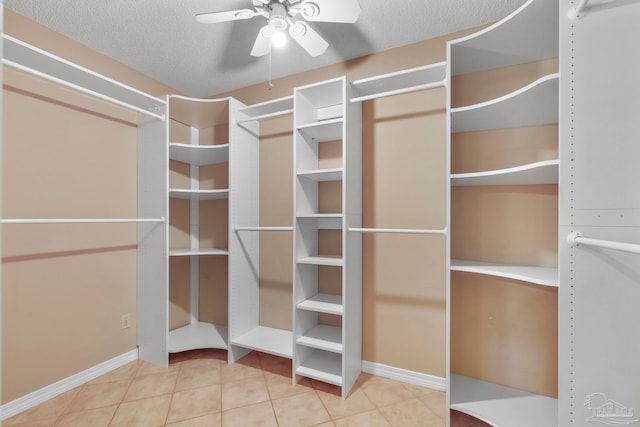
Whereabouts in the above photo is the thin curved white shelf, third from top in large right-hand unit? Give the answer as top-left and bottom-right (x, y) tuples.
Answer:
(451, 160), (560, 187)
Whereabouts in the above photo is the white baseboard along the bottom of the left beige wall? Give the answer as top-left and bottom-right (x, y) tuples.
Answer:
(0, 349), (138, 421)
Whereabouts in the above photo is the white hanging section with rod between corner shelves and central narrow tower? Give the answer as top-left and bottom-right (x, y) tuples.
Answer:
(229, 96), (293, 363)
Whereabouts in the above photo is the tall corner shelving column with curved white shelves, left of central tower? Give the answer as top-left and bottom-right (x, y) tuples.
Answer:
(168, 95), (232, 353)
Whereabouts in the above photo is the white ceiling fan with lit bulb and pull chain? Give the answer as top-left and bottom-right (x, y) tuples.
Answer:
(196, 0), (361, 56)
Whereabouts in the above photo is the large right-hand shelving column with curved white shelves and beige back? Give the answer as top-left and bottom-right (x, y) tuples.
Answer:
(447, 0), (559, 427)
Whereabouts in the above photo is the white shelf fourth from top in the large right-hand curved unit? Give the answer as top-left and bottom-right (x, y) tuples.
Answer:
(451, 259), (558, 287)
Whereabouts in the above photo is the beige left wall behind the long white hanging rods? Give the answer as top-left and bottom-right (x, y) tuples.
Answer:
(1, 10), (175, 403)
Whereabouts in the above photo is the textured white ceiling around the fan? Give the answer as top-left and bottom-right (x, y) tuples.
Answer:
(4, 0), (525, 97)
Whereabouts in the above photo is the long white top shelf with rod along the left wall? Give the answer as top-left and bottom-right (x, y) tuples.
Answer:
(2, 34), (166, 119)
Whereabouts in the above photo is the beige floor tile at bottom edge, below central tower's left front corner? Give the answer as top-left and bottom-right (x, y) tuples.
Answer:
(272, 392), (330, 427)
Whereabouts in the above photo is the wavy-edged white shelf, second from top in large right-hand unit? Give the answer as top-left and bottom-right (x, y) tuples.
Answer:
(451, 73), (559, 133)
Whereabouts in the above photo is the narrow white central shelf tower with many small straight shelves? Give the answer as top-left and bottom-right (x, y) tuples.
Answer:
(293, 77), (362, 398)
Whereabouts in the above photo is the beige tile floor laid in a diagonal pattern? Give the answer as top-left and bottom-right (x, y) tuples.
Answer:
(1, 350), (488, 427)
